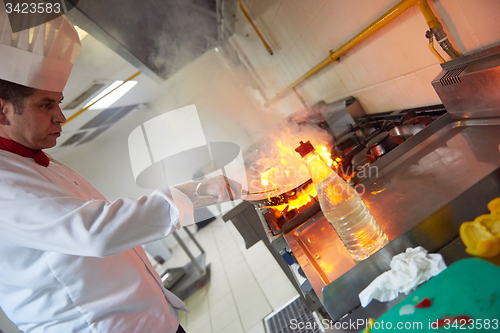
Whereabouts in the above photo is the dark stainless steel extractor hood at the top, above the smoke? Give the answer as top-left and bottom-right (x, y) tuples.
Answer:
(67, 0), (237, 80)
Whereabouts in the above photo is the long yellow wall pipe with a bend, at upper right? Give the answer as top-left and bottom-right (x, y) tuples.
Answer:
(267, 0), (461, 104)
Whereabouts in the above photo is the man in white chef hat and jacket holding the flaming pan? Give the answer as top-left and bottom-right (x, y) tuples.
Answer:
(0, 12), (241, 333)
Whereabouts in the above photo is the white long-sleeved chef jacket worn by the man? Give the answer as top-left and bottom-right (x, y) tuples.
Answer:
(0, 150), (194, 333)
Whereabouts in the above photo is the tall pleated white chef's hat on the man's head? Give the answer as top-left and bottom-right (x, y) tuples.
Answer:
(0, 6), (82, 92)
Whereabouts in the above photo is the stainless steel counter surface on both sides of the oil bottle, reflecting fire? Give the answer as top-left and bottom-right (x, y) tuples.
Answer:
(285, 118), (500, 320)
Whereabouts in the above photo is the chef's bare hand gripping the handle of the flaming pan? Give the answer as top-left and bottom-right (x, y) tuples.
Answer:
(175, 176), (241, 208)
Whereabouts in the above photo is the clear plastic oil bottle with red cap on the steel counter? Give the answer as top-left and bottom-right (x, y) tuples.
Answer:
(295, 141), (389, 261)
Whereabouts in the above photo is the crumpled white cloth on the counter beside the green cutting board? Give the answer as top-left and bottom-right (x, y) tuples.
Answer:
(359, 246), (446, 307)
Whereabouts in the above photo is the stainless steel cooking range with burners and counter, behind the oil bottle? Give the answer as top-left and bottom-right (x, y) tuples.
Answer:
(224, 45), (500, 321)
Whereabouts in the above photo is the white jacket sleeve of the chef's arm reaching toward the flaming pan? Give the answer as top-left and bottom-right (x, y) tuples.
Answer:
(0, 188), (194, 257)
